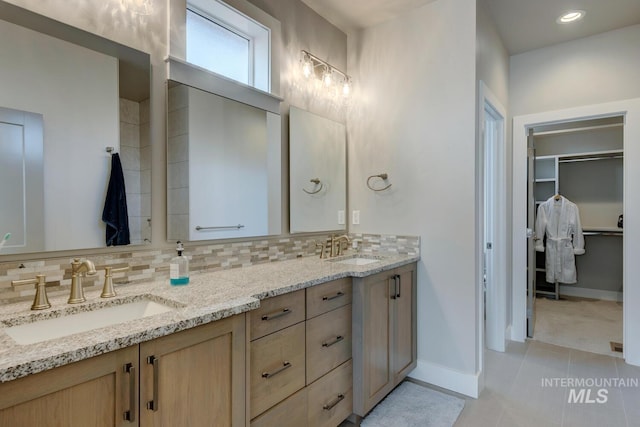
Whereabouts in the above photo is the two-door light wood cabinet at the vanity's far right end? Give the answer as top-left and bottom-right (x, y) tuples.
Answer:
(353, 263), (417, 417)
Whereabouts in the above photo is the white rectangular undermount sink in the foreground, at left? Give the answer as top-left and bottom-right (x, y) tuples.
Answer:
(4, 299), (175, 345)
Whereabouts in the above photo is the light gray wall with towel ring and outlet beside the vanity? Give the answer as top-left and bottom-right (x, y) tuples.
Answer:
(347, 0), (478, 392)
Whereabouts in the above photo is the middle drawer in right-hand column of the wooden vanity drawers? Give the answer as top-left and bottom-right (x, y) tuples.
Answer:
(306, 304), (351, 384)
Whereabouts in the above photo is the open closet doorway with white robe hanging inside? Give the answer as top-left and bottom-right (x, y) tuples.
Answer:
(527, 115), (624, 357)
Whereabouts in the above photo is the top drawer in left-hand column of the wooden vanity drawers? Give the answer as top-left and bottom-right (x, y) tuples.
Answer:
(251, 289), (305, 340)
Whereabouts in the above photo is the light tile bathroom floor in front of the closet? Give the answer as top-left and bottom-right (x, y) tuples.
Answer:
(455, 341), (640, 427)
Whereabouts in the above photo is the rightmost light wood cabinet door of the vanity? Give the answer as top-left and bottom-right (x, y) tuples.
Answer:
(391, 264), (417, 384)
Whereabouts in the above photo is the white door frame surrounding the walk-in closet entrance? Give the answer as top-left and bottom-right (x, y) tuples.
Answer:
(511, 98), (640, 366)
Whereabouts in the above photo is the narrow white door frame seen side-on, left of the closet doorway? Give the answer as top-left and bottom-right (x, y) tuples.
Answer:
(477, 80), (509, 358)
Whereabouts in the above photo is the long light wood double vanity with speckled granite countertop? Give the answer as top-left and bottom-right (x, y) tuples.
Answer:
(0, 254), (418, 426)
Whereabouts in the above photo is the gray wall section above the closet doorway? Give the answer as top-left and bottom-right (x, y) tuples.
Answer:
(509, 25), (640, 116)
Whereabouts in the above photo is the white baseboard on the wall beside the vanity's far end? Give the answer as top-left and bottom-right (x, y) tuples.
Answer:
(409, 360), (481, 399)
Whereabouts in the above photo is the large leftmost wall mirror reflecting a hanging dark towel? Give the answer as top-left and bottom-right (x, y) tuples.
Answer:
(0, 2), (151, 254)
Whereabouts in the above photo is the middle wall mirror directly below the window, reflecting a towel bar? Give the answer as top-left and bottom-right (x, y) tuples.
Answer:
(167, 81), (282, 241)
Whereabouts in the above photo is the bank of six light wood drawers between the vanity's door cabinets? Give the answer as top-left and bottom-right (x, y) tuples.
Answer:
(248, 278), (353, 427)
